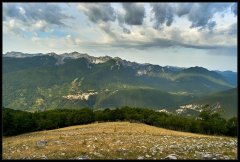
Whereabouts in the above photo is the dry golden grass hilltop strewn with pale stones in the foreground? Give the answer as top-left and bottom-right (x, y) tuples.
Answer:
(3, 122), (237, 159)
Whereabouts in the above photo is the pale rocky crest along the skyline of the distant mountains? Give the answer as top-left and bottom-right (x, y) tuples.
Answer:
(3, 51), (235, 76)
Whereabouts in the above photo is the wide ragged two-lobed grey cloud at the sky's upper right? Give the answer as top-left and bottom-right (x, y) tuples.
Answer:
(151, 3), (232, 30)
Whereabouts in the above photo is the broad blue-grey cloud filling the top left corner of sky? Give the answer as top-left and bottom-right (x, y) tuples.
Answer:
(3, 3), (72, 26)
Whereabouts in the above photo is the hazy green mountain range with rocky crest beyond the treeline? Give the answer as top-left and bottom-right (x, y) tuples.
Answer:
(2, 52), (237, 116)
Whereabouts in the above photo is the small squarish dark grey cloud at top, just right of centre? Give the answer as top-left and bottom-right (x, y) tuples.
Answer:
(122, 3), (145, 25)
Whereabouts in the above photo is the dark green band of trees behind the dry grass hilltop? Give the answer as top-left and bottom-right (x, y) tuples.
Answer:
(3, 107), (237, 136)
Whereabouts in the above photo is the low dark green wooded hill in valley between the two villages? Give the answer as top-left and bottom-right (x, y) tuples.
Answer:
(94, 88), (192, 110)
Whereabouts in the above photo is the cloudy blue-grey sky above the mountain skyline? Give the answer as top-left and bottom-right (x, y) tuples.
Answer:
(2, 2), (237, 72)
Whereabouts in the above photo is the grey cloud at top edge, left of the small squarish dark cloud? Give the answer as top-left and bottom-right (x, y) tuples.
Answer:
(81, 3), (116, 23)
